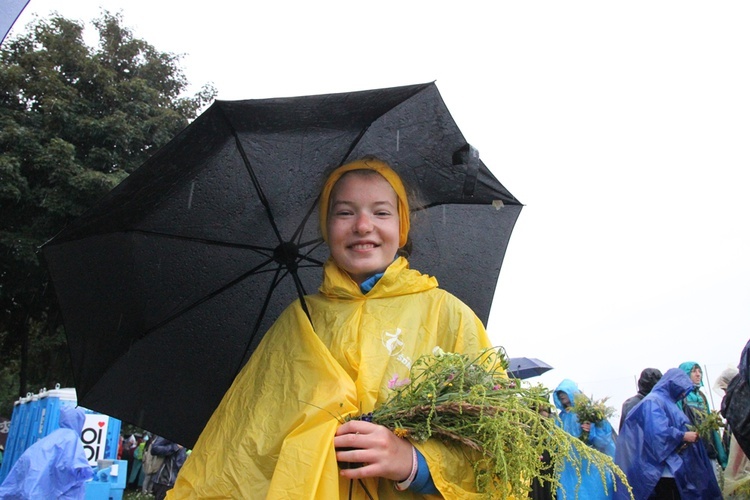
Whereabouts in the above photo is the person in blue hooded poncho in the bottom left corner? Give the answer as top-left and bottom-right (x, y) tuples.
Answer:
(0, 406), (94, 499)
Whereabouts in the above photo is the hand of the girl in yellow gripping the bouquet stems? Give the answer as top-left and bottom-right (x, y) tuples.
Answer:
(333, 420), (413, 482)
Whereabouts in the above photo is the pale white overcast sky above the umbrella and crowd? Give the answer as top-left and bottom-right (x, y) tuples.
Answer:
(11, 0), (750, 422)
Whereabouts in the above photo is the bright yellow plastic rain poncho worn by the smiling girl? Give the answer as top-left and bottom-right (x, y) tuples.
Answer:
(173, 258), (490, 500)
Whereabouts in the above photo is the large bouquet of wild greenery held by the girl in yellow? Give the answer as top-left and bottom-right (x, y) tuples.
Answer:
(354, 348), (629, 498)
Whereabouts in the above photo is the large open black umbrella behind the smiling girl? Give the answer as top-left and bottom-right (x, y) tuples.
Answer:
(44, 83), (521, 446)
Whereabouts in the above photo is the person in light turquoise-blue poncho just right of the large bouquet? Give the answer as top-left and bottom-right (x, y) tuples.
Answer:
(552, 379), (625, 499)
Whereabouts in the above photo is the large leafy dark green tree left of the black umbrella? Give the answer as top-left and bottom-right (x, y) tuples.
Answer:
(0, 11), (216, 414)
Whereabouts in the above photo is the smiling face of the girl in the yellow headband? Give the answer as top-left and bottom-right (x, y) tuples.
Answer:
(328, 171), (399, 285)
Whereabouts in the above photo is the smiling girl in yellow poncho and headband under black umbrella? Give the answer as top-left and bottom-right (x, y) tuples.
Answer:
(169, 158), (491, 499)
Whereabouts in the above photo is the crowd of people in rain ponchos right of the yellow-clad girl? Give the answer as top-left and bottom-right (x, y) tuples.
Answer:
(529, 352), (750, 500)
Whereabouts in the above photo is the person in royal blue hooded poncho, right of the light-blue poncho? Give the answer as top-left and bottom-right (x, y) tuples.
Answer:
(615, 368), (722, 500)
